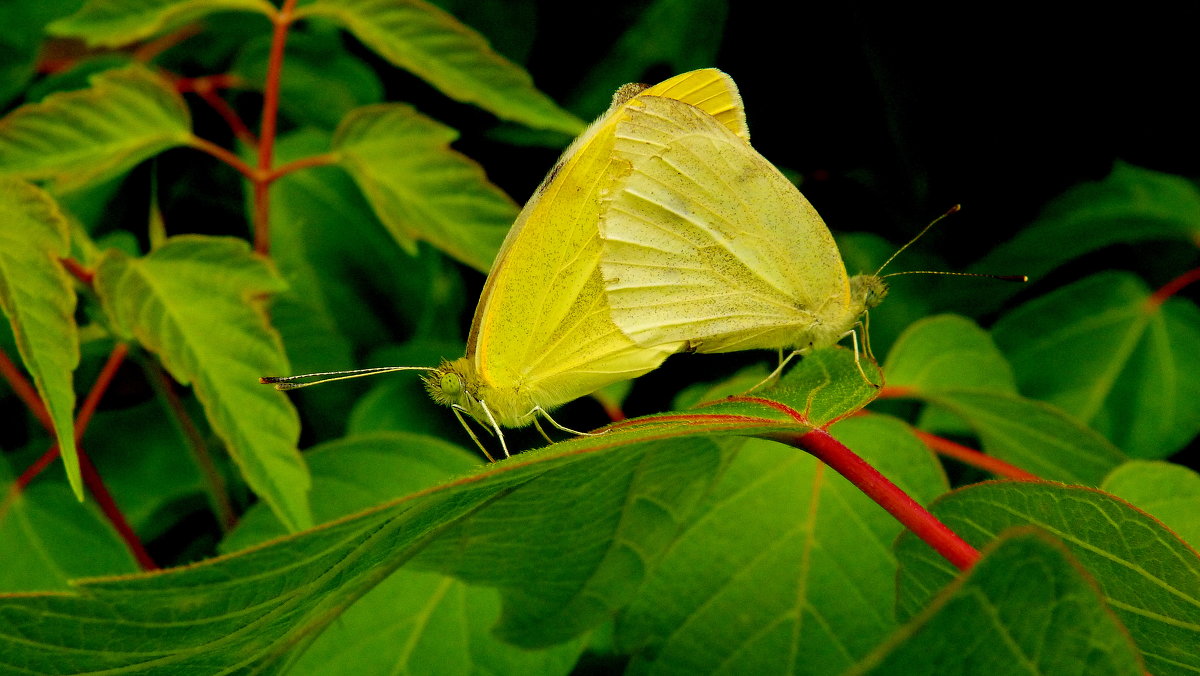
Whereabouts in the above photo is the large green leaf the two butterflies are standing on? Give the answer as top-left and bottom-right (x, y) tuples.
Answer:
(0, 349), (872, 674)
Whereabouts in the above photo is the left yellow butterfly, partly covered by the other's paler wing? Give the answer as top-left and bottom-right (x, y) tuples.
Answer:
(264, 68), (749, 459)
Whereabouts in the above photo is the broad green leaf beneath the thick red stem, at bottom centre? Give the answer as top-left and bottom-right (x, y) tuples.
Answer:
(617, 415), (947, 674)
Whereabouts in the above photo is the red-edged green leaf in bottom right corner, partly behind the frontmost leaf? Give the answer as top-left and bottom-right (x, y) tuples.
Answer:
(896, 481), (1200, 676)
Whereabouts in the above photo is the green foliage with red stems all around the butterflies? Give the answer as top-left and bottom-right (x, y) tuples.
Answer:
(0, 0), (1200, 675)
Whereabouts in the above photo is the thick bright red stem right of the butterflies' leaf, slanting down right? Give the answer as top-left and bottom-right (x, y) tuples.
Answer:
(774, 430), (979, 570)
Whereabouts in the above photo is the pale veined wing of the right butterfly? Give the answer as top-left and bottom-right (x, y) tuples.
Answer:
(601, 96), (853, 352)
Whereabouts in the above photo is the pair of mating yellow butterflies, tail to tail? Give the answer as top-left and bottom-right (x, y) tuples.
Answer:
(263, 68), (979, 459)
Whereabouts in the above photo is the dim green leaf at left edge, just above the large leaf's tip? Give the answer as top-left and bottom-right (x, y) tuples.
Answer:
(0, 463), (138, 592)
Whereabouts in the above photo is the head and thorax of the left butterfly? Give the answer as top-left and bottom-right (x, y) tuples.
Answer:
(425, 357), (536, 427)
